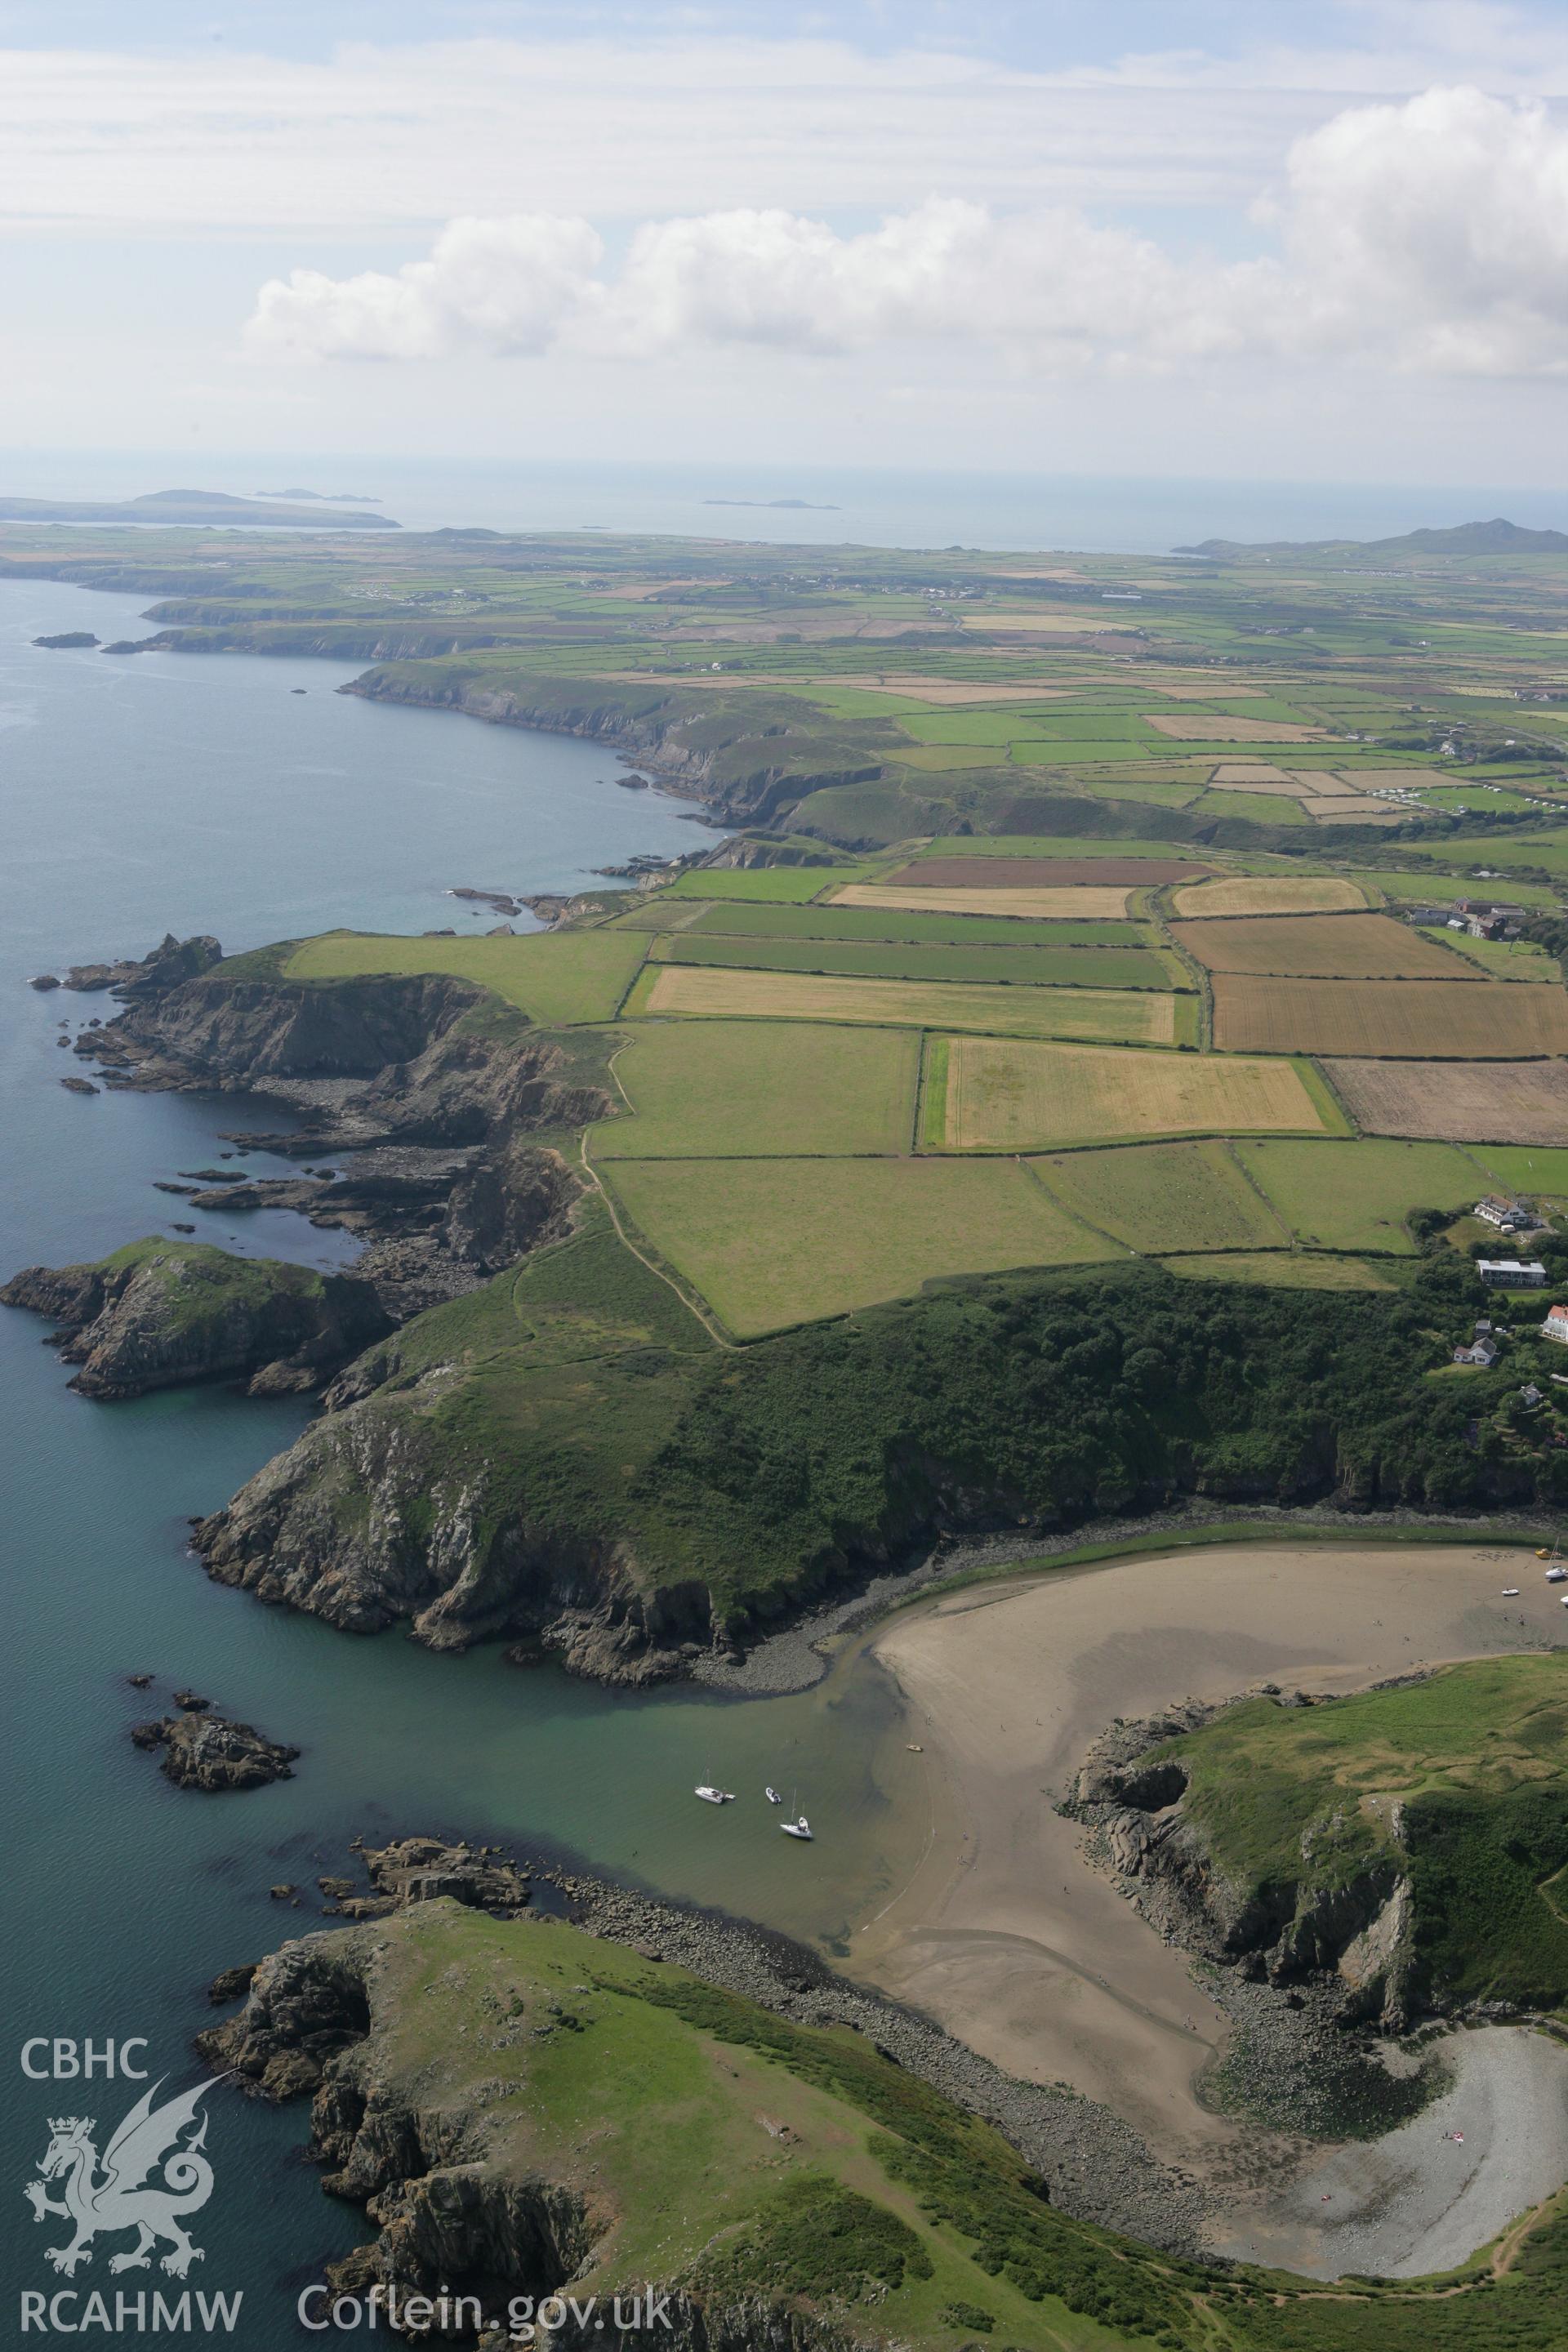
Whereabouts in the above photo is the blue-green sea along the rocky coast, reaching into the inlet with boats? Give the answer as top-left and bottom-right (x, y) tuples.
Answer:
(0, 578), (924, 2352)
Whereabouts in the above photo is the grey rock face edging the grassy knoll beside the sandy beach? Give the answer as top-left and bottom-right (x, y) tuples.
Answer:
(1060, 1686), (1415, 2032)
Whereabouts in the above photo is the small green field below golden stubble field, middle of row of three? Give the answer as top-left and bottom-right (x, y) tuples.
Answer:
(1032, 1141), (1288, 1256)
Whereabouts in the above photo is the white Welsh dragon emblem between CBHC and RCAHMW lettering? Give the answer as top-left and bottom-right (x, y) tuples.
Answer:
(21, 2077), (212, 2279)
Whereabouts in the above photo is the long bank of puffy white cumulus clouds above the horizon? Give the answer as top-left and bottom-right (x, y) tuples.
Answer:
(247, 89), (1568, 374)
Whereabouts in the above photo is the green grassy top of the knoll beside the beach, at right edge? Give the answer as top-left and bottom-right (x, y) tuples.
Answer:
(1159, 1654), (1568, 2009)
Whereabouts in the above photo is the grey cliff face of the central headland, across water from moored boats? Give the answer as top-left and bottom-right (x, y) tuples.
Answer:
(195, 1366), (715, 1686)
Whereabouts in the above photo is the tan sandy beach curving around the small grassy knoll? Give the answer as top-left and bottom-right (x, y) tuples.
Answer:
(851, 1543), (1568, 2267)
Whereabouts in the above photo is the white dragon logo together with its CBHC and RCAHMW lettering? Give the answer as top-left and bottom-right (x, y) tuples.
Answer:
(21, 2034), (244, 2336)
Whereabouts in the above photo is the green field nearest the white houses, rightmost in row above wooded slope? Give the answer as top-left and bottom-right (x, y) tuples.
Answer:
(1236, 1136), (1494, 1256)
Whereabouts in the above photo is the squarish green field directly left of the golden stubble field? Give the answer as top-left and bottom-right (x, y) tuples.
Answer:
(590, 1021), (920, 1160)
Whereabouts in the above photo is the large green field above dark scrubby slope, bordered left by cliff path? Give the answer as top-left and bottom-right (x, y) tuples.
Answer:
(604, 1160), (1121, 1339)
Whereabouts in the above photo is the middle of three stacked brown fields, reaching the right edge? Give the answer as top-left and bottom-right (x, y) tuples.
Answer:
(1213, 971), (1568, 1061)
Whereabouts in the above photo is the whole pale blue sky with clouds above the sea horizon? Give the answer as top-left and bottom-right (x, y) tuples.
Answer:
(0, 0), (1568, 480)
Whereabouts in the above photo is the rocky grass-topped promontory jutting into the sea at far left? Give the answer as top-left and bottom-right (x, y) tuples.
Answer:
(0, 1242), (390, 1400)
